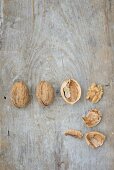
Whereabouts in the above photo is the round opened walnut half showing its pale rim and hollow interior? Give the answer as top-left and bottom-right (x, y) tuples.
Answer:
(61, 79), (81, 104)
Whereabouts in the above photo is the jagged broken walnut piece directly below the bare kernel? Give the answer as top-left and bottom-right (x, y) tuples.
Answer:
(82, 109), (101, 128)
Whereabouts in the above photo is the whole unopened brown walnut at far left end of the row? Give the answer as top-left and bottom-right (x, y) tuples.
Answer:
(11, 81), (30, 108)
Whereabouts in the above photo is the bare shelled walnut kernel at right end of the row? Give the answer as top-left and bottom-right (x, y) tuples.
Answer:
(86, 83), (103, 103)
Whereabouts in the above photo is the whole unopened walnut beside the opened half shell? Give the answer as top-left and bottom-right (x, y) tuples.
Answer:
(36, 81), (55, 106)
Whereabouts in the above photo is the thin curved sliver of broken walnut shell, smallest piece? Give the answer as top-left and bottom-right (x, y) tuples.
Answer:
(64, 129), (83, 139)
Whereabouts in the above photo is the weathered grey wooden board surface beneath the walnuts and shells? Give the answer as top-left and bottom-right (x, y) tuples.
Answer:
(0, 0), (114, 170)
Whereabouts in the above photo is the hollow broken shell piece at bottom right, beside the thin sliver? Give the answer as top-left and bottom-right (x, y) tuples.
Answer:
(85, 131), (106, 148)
